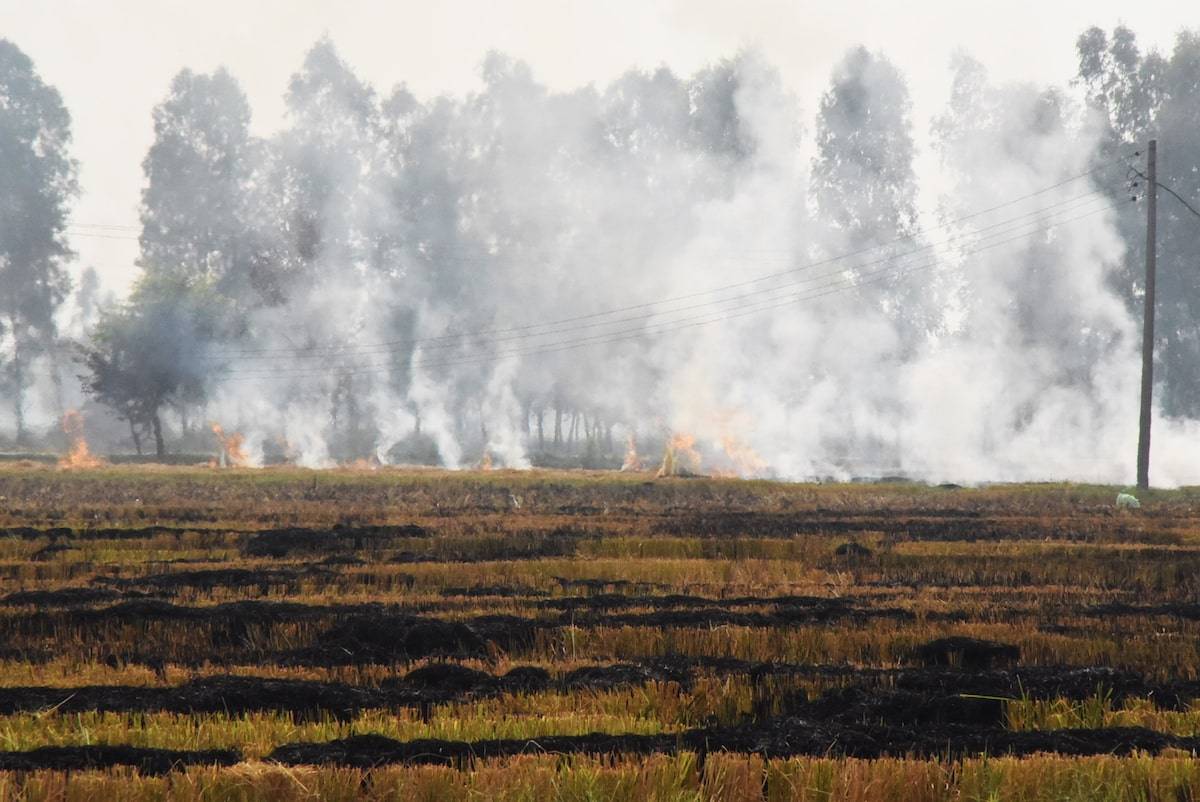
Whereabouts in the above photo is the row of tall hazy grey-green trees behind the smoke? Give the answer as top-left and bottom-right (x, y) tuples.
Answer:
(0, 28), (1200, 461)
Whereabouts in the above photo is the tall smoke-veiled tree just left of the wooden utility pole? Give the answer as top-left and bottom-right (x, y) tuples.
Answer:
(934, 55), (1122, 388)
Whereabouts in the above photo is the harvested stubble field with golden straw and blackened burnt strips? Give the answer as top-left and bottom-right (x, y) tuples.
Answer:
(0, 465), (1200, 802)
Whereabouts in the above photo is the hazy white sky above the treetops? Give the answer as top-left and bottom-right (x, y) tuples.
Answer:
(0, 0), (1200, 289)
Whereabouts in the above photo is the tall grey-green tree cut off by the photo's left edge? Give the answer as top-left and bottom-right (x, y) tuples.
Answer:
(0, 38), (78, 442)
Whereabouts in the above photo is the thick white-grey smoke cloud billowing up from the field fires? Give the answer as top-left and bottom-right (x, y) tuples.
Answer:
(121, 42), (1200, 485)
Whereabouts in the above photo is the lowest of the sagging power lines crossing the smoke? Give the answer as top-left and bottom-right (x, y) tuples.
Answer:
(213, 204), (1115, 381)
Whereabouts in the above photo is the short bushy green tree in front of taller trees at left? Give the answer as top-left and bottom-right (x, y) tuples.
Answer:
(79, 275), (224, 456)
